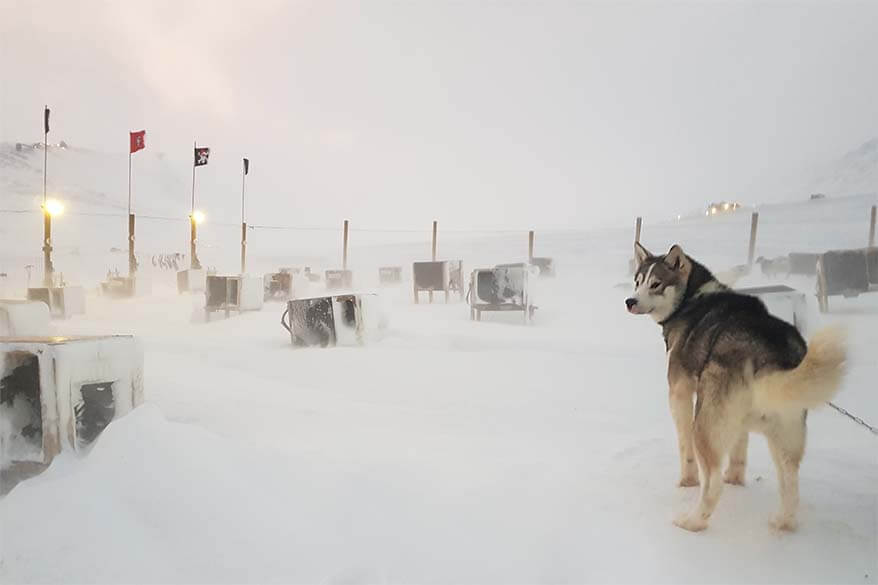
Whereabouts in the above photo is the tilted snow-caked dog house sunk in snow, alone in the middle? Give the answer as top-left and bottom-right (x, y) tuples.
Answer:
(280, 294), (383, 347)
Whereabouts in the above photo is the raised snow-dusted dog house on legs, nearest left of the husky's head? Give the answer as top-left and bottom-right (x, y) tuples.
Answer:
(469, 264), (535, 323)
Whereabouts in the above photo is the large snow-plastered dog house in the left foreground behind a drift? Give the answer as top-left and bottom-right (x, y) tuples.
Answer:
(0, 335), (143, 468)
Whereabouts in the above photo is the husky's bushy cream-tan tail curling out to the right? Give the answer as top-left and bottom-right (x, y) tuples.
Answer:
(753, 326), (847, 412)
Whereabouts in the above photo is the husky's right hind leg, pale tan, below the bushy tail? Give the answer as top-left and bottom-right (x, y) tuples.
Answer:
(765, 412), (806, 531)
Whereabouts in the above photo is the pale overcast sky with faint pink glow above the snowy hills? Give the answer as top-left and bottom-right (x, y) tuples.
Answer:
(0, 0), (878, 228)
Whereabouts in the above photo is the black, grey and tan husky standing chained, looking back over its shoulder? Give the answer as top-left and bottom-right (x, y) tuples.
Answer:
(625, 243), (845, 531)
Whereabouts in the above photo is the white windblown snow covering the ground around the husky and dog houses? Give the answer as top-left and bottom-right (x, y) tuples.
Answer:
(0, 197), (878, 583)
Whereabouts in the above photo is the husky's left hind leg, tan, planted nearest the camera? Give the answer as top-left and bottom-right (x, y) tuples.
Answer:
(674, 370), (749, 532)
